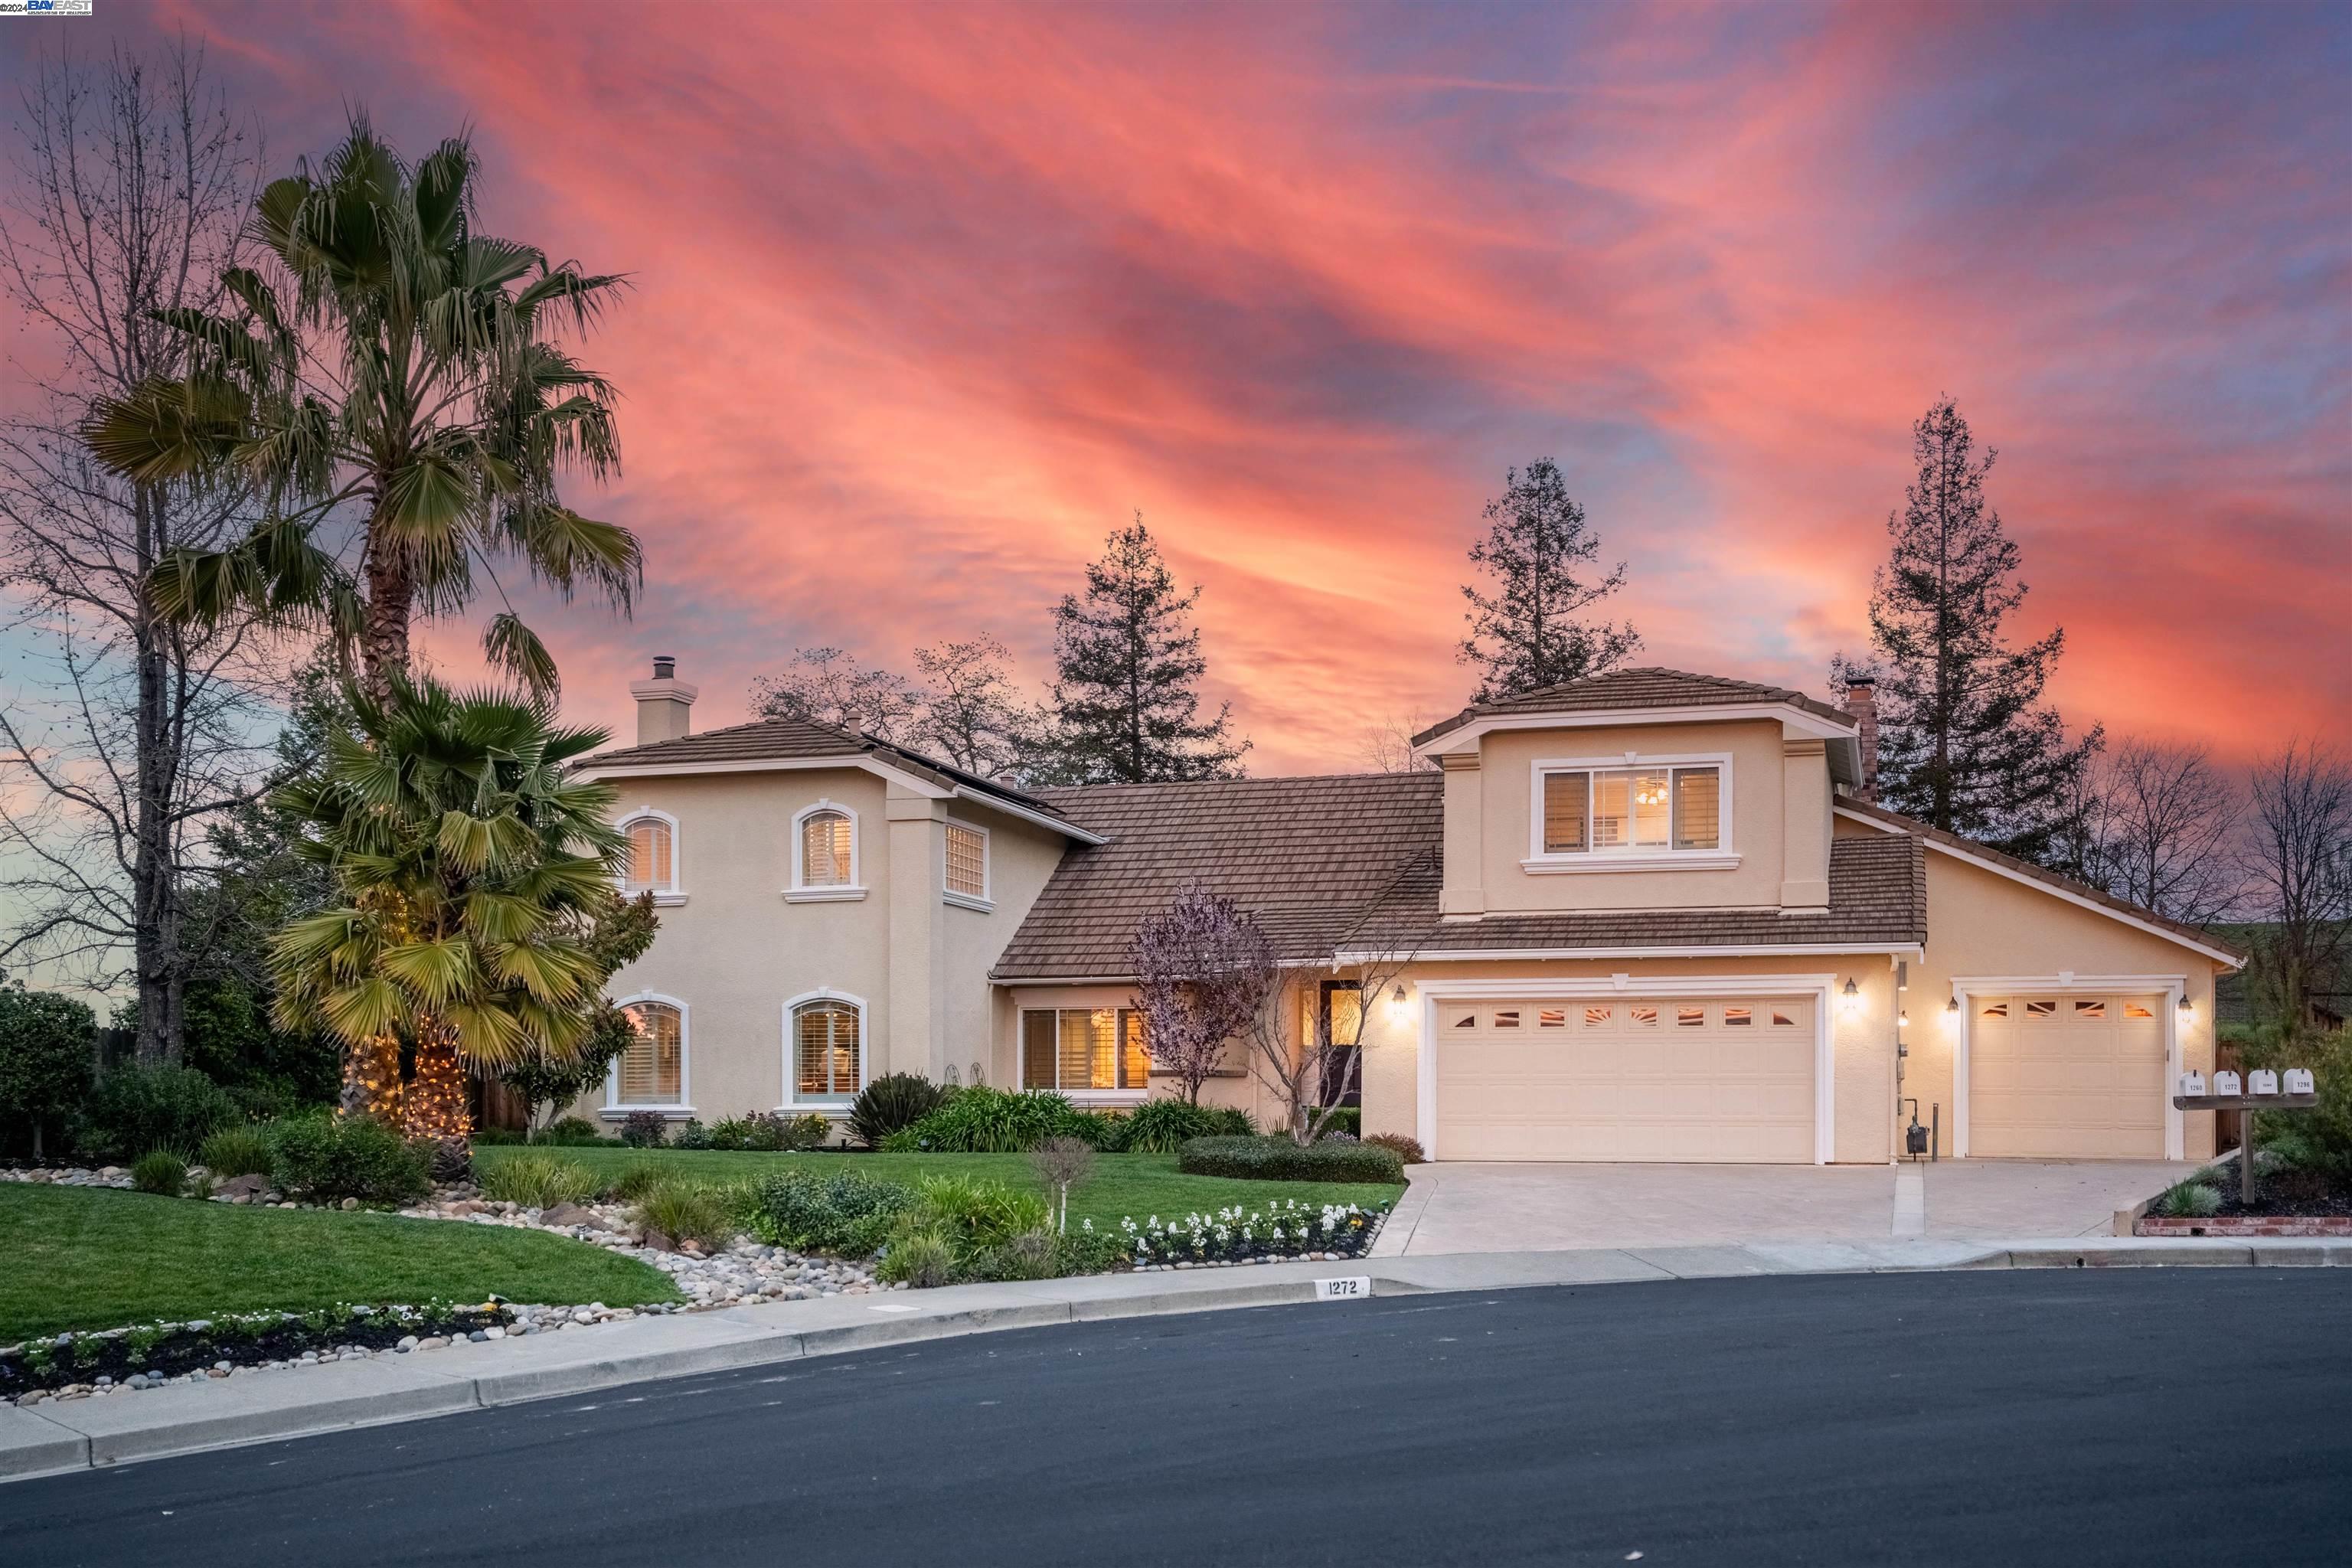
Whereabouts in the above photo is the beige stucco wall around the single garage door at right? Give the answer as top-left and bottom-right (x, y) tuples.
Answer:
(1837, 818), (2218, 1159)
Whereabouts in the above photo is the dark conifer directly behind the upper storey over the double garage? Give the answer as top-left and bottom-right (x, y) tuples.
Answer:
(1461, 459), (1642, 703)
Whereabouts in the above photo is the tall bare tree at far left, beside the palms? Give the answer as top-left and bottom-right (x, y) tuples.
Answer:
(0, 42), (261, 1060)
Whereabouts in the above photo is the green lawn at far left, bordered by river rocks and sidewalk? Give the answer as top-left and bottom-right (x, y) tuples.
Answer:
(0, 1182), (680, 1344)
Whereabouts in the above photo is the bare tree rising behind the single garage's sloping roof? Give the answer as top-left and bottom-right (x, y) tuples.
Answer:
(2082, 736), (2242, 924)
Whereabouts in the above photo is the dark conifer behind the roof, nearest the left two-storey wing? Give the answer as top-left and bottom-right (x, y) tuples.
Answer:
(1051, 512), (1249, 782)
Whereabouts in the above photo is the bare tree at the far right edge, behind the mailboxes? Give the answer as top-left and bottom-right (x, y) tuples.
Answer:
(2246, 740), (2352, 1027)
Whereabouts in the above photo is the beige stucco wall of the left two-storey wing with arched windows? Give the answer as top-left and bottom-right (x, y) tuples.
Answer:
(571, 766), (1060, 1122)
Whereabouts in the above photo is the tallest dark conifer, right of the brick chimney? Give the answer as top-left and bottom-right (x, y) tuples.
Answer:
(1832, 397), (2102, 865)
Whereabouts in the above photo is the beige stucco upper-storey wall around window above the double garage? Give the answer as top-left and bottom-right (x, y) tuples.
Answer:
(1446, 720), (1828, 910)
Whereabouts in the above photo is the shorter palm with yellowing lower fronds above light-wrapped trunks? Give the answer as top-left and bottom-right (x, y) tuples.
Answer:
(270, 677), (623, 1152)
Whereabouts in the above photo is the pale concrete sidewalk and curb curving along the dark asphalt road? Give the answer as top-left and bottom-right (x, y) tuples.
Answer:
(0, 1236), (2352, 1481)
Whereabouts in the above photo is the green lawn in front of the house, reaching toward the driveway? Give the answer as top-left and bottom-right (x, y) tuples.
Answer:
(472, 1145), (1404, 1230)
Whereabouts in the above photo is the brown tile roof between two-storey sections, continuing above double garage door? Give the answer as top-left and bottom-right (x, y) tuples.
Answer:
(995, 773), (1926, 980)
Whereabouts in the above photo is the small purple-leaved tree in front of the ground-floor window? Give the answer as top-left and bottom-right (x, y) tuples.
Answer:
(1134, 884), (1282, 1105)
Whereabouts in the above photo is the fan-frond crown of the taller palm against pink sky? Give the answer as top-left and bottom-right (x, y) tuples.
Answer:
(83, 115), (640, 703)
